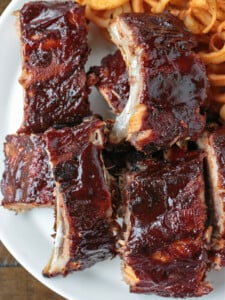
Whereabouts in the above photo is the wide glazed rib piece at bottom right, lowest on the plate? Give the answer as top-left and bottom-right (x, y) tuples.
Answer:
(121, 153), (212, 297)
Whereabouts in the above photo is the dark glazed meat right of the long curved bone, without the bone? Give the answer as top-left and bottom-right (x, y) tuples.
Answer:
(116, 13), (208, 151)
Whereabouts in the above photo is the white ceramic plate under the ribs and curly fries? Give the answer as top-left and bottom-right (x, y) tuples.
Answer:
(0, 0), (225, 300)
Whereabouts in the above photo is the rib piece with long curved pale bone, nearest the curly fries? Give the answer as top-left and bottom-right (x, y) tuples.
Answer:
(109, 13), (208, 152)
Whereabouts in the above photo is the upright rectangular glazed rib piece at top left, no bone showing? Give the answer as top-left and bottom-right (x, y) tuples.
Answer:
(19, 1), (90, 133)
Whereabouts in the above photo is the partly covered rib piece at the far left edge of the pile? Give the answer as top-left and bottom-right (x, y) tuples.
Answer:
(1, 135), (55, 212)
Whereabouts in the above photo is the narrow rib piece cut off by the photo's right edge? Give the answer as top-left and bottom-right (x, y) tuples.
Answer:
(198, 127), (225, 269)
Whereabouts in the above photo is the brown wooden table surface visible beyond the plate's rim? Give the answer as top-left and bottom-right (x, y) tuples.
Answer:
(0, 0), (64, 300)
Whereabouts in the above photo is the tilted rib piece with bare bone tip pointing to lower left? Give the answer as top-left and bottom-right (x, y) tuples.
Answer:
(43, 120), (114, 277)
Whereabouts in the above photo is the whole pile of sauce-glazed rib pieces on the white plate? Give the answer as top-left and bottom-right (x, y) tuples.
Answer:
(1, 1), (225, 297)
